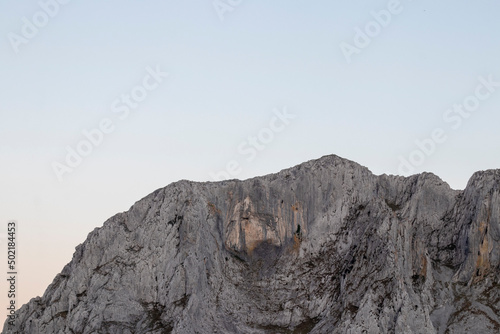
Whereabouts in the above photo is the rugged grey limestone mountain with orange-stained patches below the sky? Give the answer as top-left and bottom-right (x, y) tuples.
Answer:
(4, 156), (500, 334)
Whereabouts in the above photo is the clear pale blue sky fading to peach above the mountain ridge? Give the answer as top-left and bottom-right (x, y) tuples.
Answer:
(0, 0), (500, 320)
